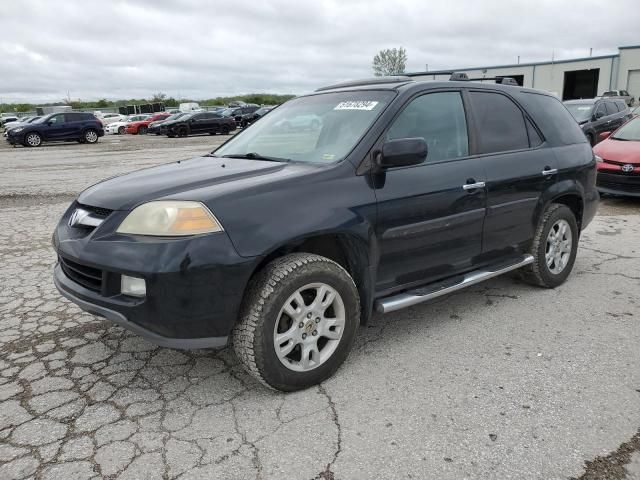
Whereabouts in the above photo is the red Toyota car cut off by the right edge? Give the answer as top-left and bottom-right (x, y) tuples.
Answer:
(593, 117), (640, 197)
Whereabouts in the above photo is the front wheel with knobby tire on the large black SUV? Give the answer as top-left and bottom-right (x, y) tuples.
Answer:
(233, 253), (360, 391)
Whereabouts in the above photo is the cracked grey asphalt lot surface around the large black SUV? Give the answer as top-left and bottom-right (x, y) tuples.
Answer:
(0, 136), (640, 480)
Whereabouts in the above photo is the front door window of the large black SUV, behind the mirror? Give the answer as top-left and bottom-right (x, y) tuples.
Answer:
(387, 92), (469, 162)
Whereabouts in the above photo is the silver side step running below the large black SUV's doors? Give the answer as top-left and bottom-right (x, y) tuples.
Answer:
(375, 255), (533, 313)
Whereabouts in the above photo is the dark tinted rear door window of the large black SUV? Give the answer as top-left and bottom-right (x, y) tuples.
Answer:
(469, 92), (529, 153)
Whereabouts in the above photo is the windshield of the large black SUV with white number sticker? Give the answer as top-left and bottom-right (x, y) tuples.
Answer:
(214, 91), (394, 163)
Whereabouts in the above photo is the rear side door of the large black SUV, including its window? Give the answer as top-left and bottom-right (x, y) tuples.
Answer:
(468, 90), (558, 260)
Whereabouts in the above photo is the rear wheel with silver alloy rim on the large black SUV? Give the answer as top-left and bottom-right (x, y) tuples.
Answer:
(525, 203), (580, 288)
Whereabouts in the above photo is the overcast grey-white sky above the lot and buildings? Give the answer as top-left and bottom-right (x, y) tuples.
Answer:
(0, 0), (640, 102)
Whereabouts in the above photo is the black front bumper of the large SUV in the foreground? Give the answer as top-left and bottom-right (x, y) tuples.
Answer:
(53, 203), (255, 349)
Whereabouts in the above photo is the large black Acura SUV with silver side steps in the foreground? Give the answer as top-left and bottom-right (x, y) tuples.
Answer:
(53, 77), (598, 390)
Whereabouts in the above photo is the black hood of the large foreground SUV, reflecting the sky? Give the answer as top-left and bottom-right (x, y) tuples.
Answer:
(78, 157), (317, 210)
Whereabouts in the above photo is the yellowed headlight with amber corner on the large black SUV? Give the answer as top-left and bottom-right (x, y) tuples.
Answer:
(117, 200), (223, 237)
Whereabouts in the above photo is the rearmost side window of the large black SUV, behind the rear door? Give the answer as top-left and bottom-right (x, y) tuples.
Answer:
(517, 92), (587, 146)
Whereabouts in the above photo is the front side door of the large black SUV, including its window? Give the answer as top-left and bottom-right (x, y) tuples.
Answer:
(372, 91), (486, 294)
